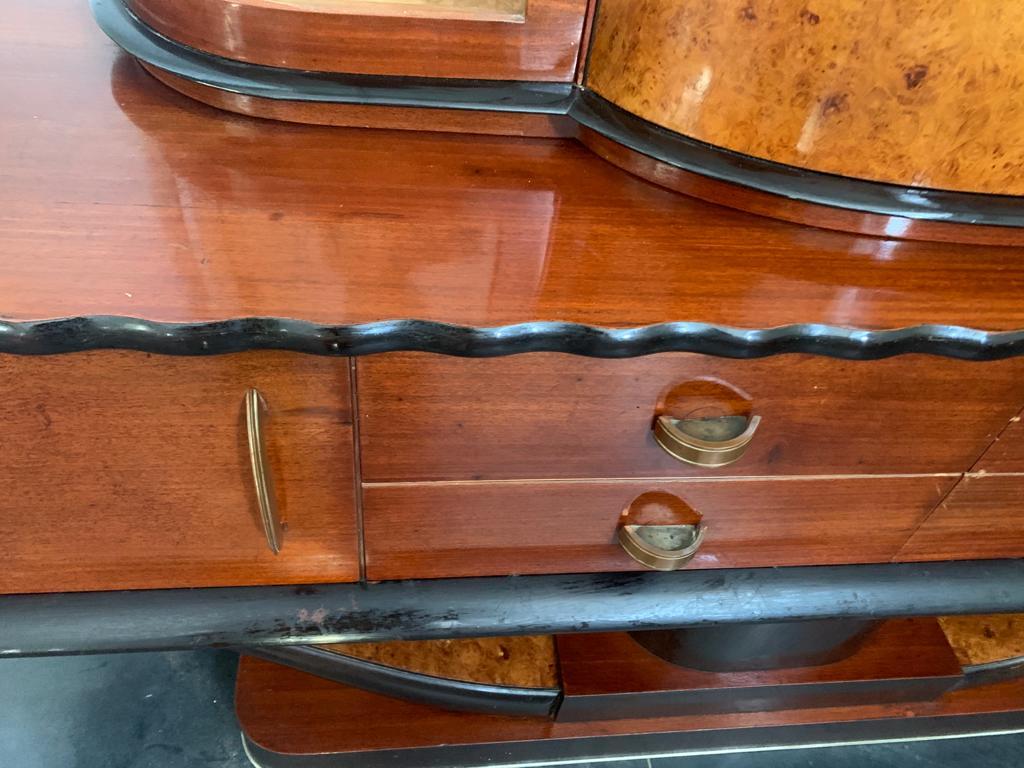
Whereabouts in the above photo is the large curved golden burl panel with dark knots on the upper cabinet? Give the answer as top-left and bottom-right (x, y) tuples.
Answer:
(587, 0), (1024, 195)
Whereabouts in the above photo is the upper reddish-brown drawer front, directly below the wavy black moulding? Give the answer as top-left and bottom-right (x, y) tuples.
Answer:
(357, 353), (1024, 481)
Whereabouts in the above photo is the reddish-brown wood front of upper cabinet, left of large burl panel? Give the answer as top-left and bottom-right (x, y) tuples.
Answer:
(126, 0), (587, 82)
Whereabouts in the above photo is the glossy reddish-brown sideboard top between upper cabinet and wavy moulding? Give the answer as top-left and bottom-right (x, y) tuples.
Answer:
(6, 0), (1024, 352)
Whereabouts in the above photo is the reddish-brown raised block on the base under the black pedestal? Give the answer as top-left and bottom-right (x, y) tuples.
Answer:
(556, 618), (963, 722)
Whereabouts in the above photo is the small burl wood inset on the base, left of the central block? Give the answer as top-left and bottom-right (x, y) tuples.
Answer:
(321, 635), (559, 688)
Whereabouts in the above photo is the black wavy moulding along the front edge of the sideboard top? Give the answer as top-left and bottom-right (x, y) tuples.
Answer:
(0, 316), (1024, 360)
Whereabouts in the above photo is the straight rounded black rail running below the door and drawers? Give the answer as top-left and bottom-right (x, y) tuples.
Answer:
(0, 560), (1024, 658)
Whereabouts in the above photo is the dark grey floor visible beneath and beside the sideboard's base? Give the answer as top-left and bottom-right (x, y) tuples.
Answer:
(0, 651), (1024, 768)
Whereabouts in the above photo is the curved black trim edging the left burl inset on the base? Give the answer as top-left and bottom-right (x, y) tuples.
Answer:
(237, 645), (561, 717)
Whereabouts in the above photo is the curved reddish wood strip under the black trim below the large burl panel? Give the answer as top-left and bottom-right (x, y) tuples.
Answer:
(581, 126), (1024, 246)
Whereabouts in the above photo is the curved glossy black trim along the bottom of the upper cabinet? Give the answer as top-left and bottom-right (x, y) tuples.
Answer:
(91, 0), (1024, 228)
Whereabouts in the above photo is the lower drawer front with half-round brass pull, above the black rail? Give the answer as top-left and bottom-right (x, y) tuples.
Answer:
(364, 476), (950, 580)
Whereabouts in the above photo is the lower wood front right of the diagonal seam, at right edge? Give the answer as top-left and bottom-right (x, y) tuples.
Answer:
(898, 474), (1024, 560)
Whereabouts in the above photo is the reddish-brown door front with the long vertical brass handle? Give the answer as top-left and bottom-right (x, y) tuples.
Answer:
(0, 351), (358, 593)
